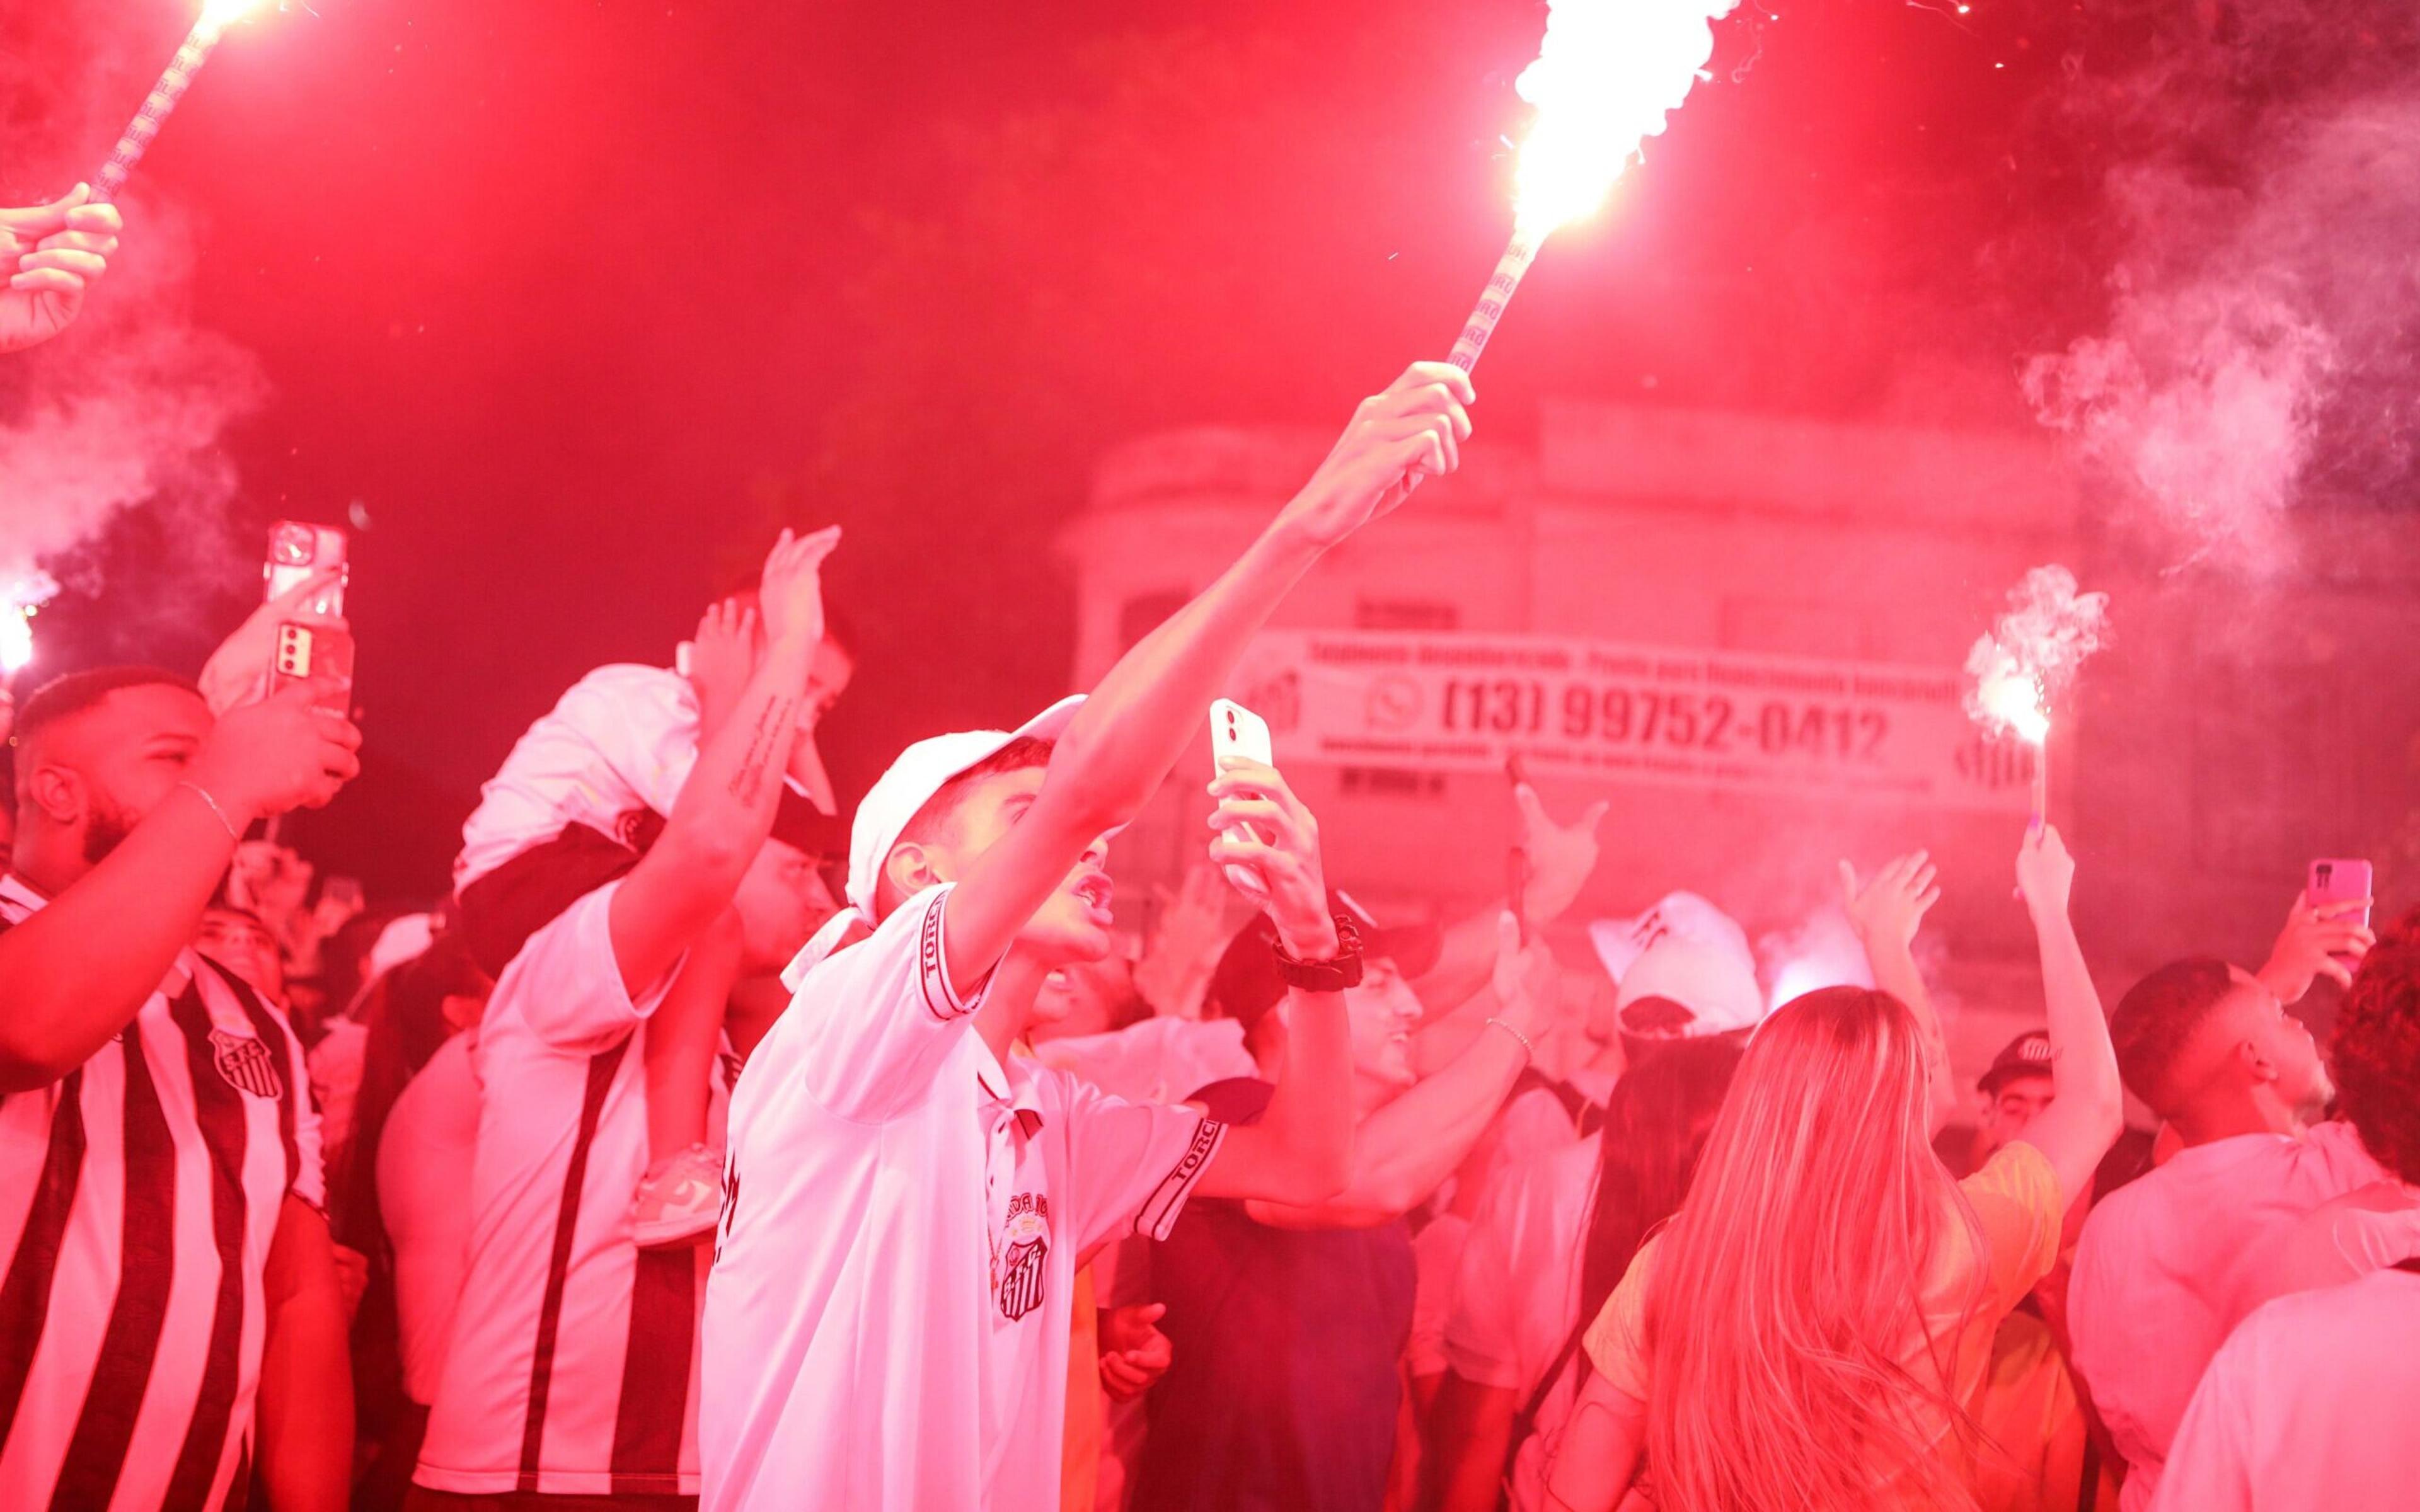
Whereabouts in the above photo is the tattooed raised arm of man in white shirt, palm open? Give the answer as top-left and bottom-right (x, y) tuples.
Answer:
(610, 530), (839, 997)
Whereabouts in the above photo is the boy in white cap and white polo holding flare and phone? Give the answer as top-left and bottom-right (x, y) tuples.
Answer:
(700, 363), (1472, 1512)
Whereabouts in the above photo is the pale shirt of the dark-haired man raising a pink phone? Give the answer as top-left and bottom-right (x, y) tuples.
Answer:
(2066, 1123), (2386, 1512)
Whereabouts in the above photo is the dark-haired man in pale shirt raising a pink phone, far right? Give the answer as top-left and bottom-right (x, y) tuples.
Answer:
(2066, 885), (2383, 1512)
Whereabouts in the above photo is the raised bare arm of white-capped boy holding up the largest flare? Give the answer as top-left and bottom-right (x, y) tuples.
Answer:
(946, 363), (1472, 992)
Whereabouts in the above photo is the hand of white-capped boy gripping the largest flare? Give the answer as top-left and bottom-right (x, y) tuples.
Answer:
(1278, 363), (1476, 547)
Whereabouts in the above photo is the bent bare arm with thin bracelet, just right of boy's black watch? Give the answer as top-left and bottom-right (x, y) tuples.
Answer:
(1251, 915), (1556, 1229)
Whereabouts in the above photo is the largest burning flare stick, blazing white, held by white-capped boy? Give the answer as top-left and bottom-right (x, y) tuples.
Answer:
(1444, 0), (1737, 372)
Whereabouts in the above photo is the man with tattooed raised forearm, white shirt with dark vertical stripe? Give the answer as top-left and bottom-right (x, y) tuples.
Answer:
(421, 532), (856, 1507)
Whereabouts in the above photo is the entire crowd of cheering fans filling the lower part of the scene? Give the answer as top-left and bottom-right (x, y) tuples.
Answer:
(0, 196), (2420, 1512)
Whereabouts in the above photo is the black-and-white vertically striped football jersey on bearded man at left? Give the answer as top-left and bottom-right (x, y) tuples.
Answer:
(0, 873), (326, 1512)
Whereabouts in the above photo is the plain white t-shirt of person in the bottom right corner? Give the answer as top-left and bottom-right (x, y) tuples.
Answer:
(2127, 1270), (2420, 1512)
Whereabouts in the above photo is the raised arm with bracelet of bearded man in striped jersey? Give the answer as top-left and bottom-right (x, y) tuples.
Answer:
(0, 682), (360, 1094)
